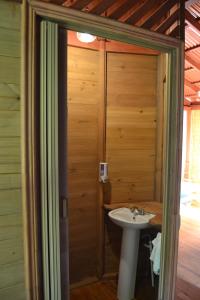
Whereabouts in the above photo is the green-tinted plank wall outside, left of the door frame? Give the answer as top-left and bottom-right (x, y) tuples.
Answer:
(0, 1), (25, 300)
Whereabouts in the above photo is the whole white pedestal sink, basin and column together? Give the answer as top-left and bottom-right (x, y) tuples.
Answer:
(108, 208), (155, 300)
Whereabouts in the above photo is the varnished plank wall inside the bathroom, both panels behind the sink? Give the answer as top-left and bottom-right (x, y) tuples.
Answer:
(67, 46), (158, 285)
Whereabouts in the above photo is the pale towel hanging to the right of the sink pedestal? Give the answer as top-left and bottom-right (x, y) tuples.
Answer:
(150, 232), (161, 275)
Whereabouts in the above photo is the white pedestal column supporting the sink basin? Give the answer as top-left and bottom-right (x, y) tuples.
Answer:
(117, 228), (140, 300)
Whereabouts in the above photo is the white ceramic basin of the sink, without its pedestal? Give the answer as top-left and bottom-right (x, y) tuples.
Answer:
(108, 207), (155, 229)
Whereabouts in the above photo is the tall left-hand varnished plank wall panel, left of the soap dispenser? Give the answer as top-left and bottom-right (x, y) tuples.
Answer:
(67, 46), (100, 284)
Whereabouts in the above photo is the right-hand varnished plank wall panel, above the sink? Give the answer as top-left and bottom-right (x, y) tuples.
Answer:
(106, 53), (157, 202)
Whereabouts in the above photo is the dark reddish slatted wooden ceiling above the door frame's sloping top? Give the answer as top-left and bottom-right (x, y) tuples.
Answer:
(43, 0), (184, 39)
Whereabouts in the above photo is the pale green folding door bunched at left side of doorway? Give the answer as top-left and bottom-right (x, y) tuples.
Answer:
(40, 21), (61, 300)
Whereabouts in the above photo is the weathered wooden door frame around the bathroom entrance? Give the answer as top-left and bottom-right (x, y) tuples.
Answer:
(21, 0), (184, 300)
